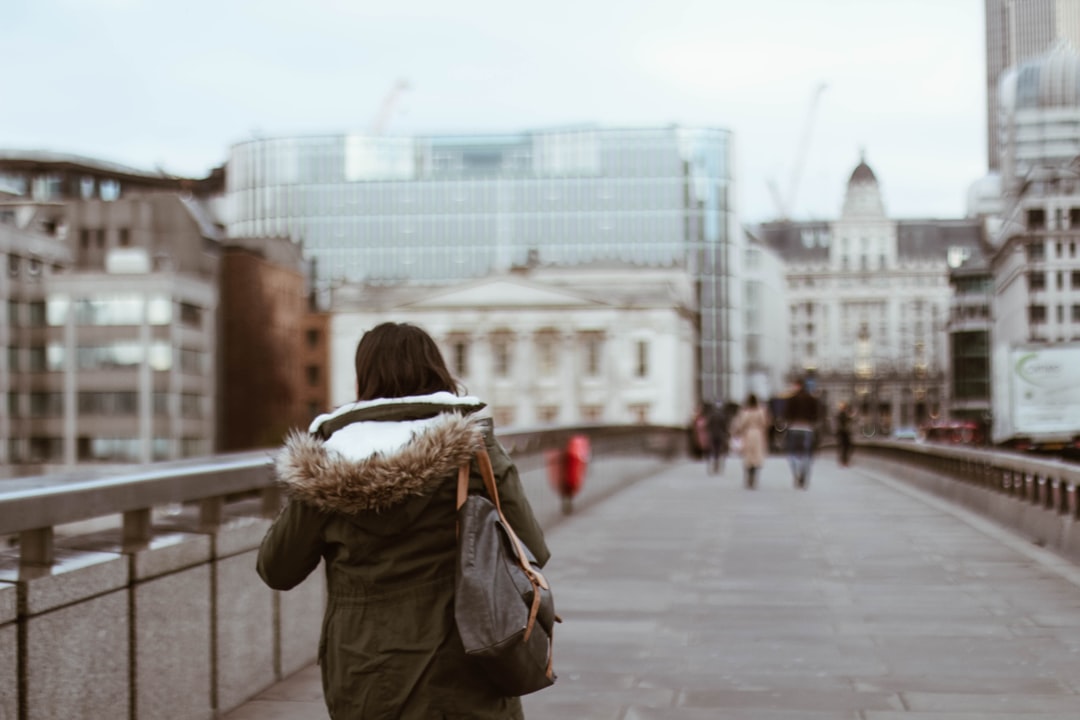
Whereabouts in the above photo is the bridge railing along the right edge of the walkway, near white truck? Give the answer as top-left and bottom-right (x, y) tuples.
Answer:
(856, 440), (1080, 562)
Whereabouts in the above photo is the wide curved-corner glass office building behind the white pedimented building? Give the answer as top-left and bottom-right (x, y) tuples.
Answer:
(227, 126), (742, 399)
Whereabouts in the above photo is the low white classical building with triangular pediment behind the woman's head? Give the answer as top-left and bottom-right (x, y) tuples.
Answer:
(329, 266), (697, 427)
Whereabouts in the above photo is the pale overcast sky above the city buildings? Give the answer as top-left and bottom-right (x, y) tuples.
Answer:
(0, 0), (986, 222)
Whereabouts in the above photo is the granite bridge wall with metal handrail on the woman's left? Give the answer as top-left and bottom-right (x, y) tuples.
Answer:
(0, 426), (685, 720)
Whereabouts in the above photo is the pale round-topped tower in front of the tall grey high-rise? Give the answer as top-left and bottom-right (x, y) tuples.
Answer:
(998, 40), (1080, 190)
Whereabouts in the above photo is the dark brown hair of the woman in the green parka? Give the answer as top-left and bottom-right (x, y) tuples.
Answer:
(356, 323), (458, 400)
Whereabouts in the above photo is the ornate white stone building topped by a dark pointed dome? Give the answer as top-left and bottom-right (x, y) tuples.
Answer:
(759, 161), (982, 433)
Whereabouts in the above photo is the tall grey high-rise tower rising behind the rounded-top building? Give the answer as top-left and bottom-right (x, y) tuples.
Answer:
(986, 0), (1080, 171)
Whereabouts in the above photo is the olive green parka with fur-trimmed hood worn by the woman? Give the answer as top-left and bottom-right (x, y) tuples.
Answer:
(258, 393), (550, 720)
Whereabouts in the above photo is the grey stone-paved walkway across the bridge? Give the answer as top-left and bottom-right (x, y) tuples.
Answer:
(226, 454), (1080, 720)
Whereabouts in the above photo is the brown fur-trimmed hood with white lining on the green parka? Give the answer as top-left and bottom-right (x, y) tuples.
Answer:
(274, 393), (489, 515)
